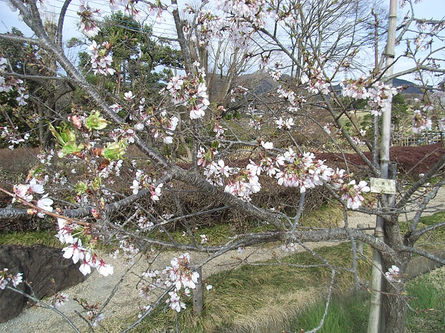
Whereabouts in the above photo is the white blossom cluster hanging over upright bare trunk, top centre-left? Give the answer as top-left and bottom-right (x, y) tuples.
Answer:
(165, 63), (210, 119)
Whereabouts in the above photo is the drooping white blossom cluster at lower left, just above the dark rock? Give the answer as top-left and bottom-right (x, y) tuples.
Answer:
(57, 218), (113, 276)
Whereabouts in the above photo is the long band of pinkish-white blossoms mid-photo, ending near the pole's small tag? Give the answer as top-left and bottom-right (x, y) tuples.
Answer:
(198, 147), (370, 209)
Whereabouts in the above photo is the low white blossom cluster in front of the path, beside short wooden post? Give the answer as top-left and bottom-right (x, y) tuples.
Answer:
(139, 253), (199, 312)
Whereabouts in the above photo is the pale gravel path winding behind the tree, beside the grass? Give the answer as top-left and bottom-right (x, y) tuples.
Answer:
(0, 188), (445, 333)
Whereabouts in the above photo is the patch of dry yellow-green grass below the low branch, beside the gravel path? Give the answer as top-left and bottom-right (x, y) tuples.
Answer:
(107, 243), (370, 333)
